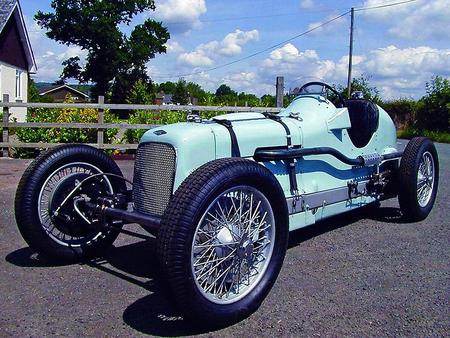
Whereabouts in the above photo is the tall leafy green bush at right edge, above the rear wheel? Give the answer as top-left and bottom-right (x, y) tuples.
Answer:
(416, 76), (450, 133)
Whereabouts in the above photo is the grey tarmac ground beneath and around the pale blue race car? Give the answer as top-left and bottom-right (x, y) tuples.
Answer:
(0, 144), (450, 337)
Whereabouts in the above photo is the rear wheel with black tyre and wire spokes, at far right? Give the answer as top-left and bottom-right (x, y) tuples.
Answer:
(398, 137), (439, 222)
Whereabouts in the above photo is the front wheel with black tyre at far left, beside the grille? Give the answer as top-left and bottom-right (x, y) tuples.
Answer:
(15, 144), (126, 263)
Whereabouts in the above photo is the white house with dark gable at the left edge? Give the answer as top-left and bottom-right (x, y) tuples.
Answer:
(0, 0), (37, 122)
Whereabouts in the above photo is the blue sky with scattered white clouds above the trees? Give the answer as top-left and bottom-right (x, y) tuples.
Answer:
(20, 0), (450, 99)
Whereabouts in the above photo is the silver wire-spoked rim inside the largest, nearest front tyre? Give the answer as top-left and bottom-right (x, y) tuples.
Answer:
(191, 186), (275, 304)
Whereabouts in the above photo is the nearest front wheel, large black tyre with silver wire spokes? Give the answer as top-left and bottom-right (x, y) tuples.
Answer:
(158, 158), (288, 327)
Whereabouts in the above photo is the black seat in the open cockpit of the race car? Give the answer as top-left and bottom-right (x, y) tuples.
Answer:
(345, 99), (379, 148)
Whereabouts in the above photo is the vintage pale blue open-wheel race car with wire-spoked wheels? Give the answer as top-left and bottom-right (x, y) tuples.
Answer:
(15, 82), (439, 325)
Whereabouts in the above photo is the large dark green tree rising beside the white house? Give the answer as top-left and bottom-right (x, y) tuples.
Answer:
(35, 0), (170, 99)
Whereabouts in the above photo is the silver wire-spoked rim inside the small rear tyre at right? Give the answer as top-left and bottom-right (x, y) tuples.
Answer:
(417, 151), (435, 207)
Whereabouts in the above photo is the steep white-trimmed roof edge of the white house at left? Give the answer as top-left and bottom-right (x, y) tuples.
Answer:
(0, 0), (37, 73)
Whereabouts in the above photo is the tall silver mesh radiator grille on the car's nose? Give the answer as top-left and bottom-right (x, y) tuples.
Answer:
(133, 142), (176, 216)
